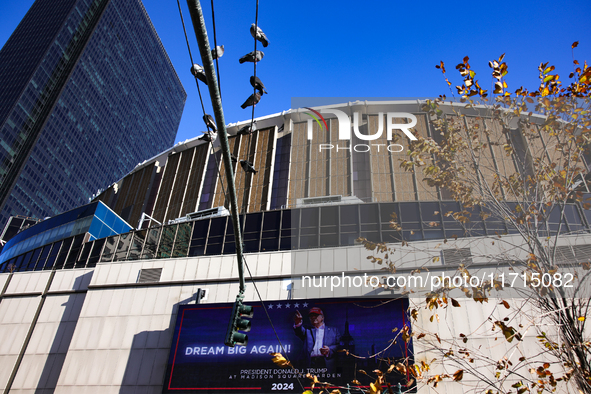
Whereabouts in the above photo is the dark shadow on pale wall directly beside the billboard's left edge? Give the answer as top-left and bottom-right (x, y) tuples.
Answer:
(119, 293), (197, 394)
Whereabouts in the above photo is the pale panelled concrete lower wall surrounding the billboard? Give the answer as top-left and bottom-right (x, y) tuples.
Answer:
(0, 237), (588, 394)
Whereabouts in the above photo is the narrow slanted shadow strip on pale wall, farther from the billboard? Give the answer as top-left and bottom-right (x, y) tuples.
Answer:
(34, 272), (92, 394)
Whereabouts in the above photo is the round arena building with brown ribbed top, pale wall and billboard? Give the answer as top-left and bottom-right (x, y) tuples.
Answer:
(0, 100), (591, 393)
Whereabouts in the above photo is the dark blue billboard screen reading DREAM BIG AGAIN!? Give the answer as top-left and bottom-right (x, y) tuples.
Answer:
(163, 298), (412, 393)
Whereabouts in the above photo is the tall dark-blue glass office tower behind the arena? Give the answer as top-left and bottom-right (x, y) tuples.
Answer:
(0, 0), (186, 229)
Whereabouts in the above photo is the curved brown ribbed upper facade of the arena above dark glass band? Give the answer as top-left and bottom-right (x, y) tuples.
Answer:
(90, 100), (583, 226)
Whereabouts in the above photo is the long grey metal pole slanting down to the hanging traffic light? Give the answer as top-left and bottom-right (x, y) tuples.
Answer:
(187, 0), (246, 296)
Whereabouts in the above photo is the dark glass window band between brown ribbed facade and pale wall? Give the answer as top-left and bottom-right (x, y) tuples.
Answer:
(0, 201), (591, 273)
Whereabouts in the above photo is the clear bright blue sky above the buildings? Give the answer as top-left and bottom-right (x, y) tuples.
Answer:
(0, 0), (591, 141)
